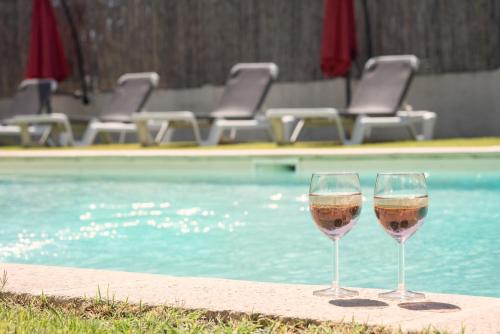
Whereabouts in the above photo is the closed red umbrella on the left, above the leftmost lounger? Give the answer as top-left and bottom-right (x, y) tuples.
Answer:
(25, 0), (70, 81)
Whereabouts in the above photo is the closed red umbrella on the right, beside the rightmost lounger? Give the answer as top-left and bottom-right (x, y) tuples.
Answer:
(321, 0), (358, 103)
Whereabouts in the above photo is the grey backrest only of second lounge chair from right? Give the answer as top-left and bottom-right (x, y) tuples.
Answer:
(210, 63), (278, 119)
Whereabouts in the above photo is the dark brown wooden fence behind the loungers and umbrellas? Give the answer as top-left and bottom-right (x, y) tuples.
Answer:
(0, 0), (500, 96)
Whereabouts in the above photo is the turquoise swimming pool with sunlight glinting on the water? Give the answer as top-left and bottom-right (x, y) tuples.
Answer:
(0, 157), (500, 297)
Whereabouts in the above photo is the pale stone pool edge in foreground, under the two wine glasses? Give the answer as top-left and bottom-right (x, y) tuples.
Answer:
(0, 263), (500, 333)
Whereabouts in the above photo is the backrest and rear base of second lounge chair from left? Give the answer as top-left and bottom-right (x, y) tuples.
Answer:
(81, 72), (160, 145)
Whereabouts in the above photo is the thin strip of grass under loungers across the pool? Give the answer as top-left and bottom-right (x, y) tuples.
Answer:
(0, 137), (500, 150)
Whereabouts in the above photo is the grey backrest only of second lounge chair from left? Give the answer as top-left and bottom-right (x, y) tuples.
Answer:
(99, 72), (160, 122)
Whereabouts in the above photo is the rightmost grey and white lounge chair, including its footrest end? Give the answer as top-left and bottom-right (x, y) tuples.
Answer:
(266, 55), (436, 144)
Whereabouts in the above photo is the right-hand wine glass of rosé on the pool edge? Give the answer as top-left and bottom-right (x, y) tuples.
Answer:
(373, 173), (428, 301)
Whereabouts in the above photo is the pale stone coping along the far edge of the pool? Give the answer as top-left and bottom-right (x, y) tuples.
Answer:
(0, 146), (500, 158)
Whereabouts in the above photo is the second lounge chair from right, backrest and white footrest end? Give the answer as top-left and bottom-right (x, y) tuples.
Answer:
(134, 63), (278, 146)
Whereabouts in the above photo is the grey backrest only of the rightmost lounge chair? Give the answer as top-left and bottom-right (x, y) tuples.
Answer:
(347, 55), (419, 116)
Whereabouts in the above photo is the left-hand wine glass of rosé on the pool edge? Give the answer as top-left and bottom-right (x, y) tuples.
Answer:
(309, 173), (362, 298)
